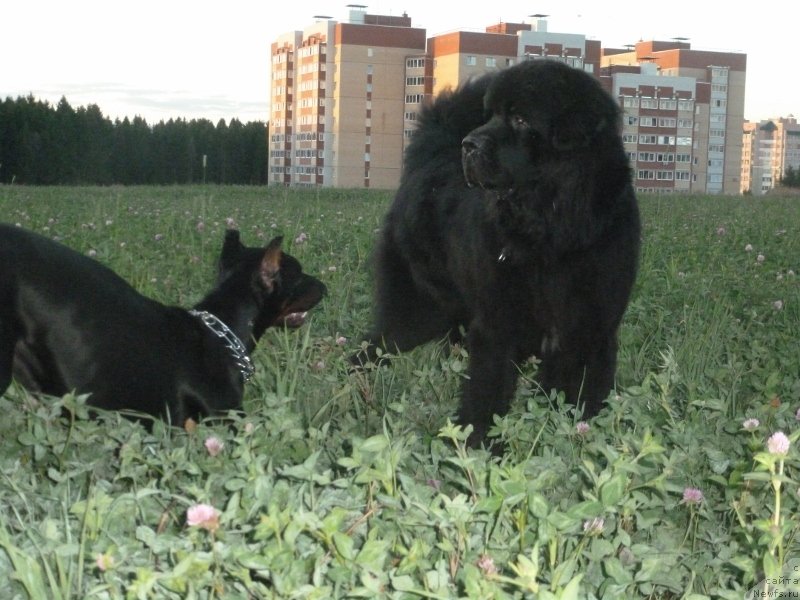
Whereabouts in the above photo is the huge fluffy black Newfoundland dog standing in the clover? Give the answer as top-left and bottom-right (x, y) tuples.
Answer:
(354, 60), (640, 444)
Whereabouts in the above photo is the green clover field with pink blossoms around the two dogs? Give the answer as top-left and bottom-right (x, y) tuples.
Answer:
(0, 186), (800, 600)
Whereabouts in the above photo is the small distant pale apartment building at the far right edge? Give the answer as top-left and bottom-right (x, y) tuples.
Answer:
(741, 116), (800, 196)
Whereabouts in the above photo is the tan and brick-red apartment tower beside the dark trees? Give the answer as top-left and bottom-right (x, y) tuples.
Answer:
(269, 5), (425, 188)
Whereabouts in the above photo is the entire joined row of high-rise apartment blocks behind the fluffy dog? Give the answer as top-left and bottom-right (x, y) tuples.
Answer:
(270, 13), (746, 194)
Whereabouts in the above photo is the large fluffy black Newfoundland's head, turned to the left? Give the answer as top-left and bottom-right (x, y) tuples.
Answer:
(462, 60), (619, 190)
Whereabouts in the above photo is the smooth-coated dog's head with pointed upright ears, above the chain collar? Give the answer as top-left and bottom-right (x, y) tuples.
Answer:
(217, 230), (326, 339)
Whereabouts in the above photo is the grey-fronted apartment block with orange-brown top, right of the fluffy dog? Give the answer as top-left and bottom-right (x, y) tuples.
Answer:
(601, 40), (747, 194)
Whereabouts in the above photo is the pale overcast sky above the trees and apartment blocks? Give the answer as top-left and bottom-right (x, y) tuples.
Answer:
(0, 0), (800, 123)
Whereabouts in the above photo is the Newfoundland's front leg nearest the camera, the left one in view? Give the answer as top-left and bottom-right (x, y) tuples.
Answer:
(458, 323), (518, 447)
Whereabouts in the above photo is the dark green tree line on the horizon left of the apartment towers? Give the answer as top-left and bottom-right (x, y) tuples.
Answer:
(0, 96), (267, 185)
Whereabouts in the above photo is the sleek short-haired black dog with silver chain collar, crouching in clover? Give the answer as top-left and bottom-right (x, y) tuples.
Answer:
(0, 225), (325, 425)
